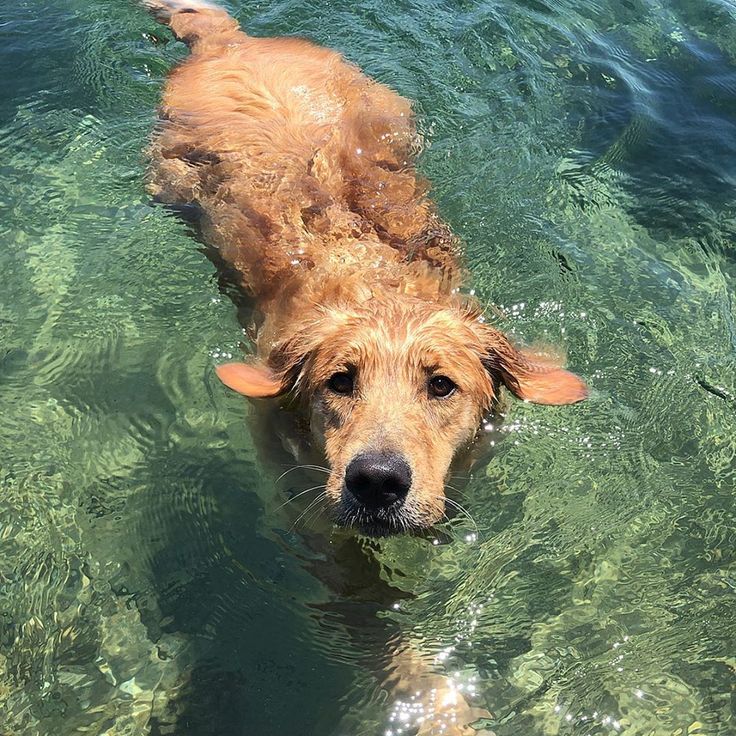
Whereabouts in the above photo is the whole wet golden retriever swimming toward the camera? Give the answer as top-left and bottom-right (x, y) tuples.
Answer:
(146, 0), (587, 535)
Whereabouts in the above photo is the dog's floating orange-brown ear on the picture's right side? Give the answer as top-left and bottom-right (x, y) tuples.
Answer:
(482, 325), (588, 404)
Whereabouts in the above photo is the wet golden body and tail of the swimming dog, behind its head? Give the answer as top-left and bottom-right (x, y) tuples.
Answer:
(148, 0), (454, 297)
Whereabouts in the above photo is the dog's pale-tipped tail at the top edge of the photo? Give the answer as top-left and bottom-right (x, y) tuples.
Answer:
(141, 0), (240, 48)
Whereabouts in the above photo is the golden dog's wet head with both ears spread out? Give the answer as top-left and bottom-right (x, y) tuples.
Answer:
(218, 301), (587, 535)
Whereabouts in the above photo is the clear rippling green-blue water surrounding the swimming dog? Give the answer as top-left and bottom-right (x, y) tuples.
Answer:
(0, 0), (736, 736)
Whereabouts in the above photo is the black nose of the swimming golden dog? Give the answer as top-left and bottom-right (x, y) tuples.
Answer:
(345, 453), (411, 508)
